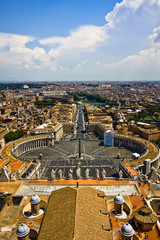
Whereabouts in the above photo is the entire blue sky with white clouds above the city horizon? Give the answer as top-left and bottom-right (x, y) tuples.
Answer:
(0, 0), (160, 82)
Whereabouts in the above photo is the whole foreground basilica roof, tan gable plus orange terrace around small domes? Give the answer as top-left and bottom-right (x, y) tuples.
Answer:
(0, 179), (159, 240)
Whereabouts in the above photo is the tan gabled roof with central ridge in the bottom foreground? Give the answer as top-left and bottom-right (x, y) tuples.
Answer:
(38, 187), (112, 240)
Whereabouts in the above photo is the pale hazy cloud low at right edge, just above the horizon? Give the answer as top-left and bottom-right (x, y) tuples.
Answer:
(105, 48), (160, 80)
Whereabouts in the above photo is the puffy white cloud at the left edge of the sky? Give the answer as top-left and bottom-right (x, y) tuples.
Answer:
(0, 33), (50, 70)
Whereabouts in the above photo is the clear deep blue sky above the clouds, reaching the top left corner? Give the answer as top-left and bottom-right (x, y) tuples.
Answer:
(0, 0), (116, 38)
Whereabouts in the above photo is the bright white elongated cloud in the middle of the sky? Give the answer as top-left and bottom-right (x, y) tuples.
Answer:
(39, 25), (108, 58)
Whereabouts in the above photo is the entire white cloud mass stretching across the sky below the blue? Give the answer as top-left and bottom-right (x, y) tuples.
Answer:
(0, 0), (160, 80)
